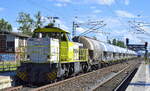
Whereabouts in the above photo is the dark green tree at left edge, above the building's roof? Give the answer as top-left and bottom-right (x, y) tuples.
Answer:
(0, 18), (12, 31)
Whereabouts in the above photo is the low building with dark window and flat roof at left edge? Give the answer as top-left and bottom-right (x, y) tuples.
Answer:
(0, 31), (29, 62)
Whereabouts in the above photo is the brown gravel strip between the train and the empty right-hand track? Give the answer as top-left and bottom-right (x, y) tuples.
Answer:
(34, 60), (141, 91)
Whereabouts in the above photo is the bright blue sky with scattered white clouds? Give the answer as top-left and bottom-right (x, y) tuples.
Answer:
(0, 0), (150, 49)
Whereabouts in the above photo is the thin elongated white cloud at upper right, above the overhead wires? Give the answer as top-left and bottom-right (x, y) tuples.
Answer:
(115, 10), (136, 18)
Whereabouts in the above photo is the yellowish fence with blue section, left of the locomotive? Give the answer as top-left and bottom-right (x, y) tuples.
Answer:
(0, 47), (25, 72)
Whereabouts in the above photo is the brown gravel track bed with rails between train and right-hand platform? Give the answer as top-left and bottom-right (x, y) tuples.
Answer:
(1, 60), (139, 91)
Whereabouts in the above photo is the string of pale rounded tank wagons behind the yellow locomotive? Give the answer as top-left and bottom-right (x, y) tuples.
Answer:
(73, 36), (136, 64)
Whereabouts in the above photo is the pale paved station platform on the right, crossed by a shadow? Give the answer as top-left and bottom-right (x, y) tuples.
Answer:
(126, 62), (150, 91)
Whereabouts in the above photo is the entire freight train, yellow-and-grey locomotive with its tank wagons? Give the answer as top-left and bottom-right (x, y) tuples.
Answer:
(17, 26), (136, 84)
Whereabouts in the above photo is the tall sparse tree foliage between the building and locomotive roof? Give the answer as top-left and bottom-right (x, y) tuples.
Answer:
(17, 12), (44, 35)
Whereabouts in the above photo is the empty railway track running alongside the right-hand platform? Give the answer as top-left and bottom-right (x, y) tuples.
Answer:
(92, 61), (139, 91)
